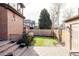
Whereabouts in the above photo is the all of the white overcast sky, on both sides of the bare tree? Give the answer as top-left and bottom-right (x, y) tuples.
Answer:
(24, 1), (79, 23)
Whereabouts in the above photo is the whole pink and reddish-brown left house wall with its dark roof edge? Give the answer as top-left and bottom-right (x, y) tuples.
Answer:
(0, 4), (25, 40)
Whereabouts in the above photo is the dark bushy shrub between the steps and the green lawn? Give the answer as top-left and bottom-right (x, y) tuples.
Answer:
(17, 32), (33, 46)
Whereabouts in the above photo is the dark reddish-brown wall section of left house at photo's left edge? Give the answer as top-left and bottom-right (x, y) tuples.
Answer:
(0, 6), (7, 40)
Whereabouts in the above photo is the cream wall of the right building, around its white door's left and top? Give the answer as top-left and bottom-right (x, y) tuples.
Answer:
(62, 19), (79, 50)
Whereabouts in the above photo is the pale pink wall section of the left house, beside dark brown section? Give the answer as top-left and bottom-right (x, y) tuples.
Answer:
(7, 10), (23, 39)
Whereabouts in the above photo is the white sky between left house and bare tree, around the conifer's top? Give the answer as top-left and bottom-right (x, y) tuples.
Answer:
(24, 3), (50, 23)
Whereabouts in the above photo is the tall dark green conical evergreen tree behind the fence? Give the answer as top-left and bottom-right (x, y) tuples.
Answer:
(39, 9), (52, 29)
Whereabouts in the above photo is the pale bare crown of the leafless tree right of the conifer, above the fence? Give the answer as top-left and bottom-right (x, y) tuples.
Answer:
(51, 3), (64, 27)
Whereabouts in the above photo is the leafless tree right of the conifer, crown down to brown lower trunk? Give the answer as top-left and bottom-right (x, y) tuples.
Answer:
(52, 3), (63, 41)
